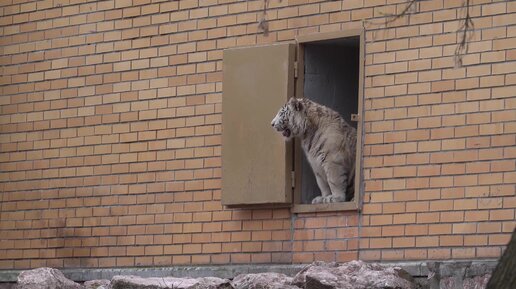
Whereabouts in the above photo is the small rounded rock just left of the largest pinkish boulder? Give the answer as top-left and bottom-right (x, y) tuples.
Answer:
(231, 272), (299, 289)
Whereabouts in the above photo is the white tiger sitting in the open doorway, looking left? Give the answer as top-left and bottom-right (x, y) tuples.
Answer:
(271, 98), (357, 204)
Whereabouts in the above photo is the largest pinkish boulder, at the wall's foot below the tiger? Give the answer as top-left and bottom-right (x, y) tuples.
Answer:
(292, 261), (416, 289)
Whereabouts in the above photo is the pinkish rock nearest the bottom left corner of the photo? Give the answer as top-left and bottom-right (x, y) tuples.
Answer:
(16, 268), (84, 289)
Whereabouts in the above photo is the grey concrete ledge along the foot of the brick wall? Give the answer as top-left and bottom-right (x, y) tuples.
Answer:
(0, 259), (498, 283)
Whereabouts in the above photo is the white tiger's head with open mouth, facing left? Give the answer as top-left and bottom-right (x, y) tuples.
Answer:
(271, 97), (306, 141)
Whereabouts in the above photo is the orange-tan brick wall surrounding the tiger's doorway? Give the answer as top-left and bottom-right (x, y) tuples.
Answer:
(0, 0), (516, 269)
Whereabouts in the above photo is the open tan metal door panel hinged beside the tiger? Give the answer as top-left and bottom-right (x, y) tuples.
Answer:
(222, 44), (295, 206)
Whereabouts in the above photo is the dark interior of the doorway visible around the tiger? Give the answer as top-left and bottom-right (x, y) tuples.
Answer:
(301, 36), (360, 204)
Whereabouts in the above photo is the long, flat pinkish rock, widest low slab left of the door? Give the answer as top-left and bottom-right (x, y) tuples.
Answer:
(110, 276), (231, 289)
